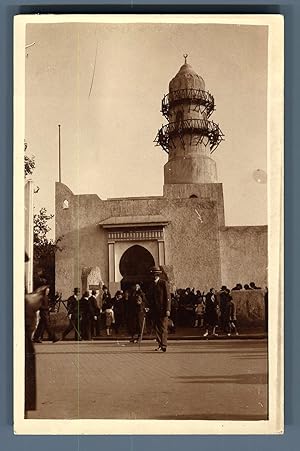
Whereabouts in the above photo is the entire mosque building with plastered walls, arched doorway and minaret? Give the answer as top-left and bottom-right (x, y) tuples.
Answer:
(55, 56), (268, 297)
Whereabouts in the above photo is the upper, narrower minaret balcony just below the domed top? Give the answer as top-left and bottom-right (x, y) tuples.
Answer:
(161, 88), (215, 119)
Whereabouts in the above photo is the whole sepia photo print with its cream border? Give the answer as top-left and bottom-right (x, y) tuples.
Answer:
(14, 15), (283, 434)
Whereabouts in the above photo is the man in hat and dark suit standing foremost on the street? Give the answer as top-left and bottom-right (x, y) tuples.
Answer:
(150, 266), (171, 352)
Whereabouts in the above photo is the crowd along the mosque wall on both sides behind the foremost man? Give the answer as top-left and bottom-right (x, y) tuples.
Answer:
(33, 282), (268, 343)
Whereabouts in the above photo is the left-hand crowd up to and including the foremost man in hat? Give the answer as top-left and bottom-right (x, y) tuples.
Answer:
(33, 267), (172, 351)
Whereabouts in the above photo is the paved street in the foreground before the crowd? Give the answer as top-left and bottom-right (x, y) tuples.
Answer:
(29, 340), (267, 420)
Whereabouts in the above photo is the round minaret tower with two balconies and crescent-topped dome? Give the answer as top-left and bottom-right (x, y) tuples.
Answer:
(155, 55), (223, 185)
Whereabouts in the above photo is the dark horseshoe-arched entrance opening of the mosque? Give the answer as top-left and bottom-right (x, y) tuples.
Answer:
(119, 244), (155, 290)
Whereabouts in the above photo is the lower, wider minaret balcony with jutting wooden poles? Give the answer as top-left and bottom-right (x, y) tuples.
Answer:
(154, 119), (224, 153)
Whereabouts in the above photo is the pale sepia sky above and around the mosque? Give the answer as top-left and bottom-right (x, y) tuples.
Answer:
(25, 20), (268, 233)
